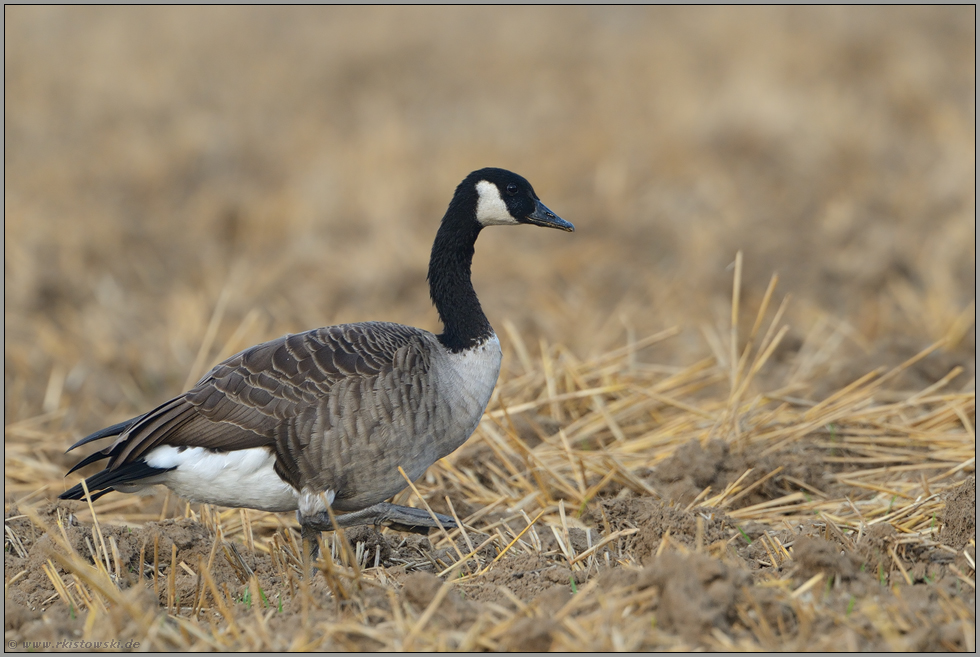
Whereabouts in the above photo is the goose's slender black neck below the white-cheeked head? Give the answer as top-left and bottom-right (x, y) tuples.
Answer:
(429, 205), (493, 351)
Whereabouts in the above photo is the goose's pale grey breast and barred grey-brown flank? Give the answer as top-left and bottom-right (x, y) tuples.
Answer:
(287, 331), (500, 511)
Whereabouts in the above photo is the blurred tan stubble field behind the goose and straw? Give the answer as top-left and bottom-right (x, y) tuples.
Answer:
(4, 6), (976, 435)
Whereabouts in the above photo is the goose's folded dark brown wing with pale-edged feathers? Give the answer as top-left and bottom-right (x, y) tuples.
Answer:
(62, 322), (431, 499)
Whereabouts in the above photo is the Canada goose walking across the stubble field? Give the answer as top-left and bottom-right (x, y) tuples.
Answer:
(60, 168), (575, 553)
